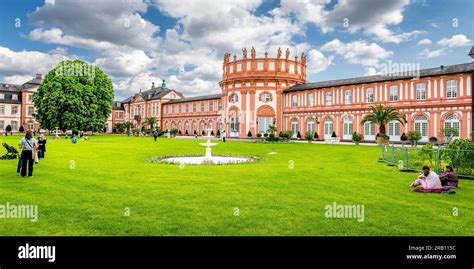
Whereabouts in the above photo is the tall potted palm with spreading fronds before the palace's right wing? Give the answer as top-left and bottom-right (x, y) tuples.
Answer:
(361, 105), (405, 144)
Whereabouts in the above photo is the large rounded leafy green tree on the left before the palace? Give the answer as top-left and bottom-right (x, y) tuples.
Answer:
(33, 60), (114, 131)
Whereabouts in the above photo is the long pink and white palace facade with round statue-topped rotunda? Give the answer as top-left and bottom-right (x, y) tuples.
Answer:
(114, 47), (474, 142)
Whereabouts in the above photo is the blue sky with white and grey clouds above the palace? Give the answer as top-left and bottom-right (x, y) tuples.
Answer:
(0, 0), (474, 100)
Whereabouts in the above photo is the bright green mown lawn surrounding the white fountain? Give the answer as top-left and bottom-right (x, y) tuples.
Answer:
(0, 136), (474, 236)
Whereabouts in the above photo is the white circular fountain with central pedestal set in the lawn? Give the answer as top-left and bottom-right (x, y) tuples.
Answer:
(161, 129), (256, 165)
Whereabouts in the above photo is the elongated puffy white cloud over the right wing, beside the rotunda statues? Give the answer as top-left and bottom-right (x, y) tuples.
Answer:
(321, 39), (393, 66)
